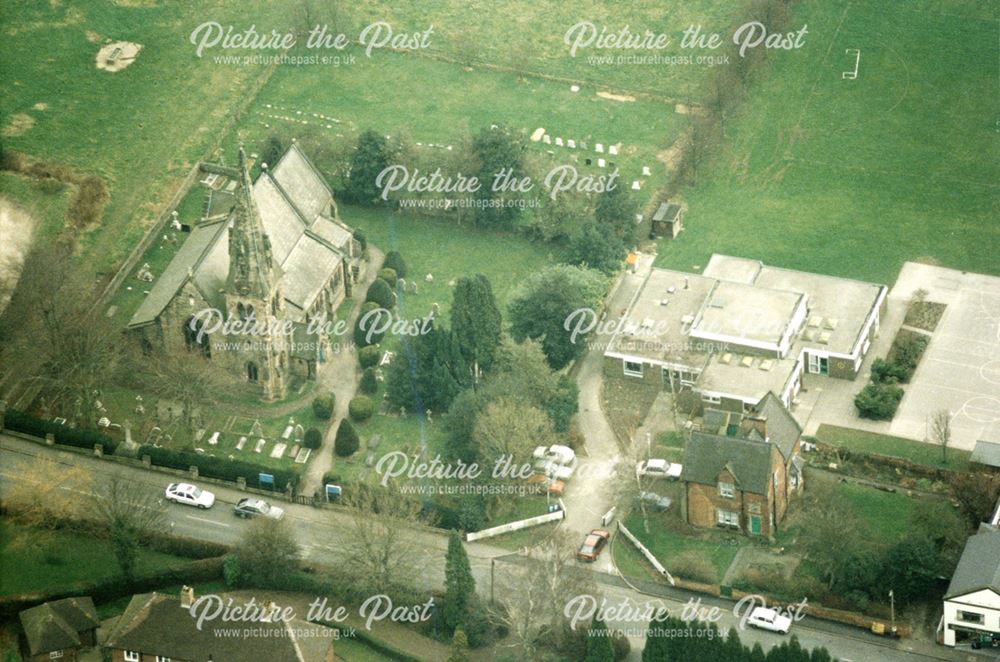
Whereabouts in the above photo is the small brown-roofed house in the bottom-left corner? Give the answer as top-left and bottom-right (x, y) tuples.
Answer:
(20, 597), (101, 662)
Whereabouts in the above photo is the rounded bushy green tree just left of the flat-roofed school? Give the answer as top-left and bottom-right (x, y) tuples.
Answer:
(510, 264), (605, 370)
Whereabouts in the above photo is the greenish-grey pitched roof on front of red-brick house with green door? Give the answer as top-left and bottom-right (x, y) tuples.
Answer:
(681, 432), (771, 495)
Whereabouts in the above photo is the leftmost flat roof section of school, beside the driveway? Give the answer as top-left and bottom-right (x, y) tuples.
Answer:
(607, 269), (716, 366)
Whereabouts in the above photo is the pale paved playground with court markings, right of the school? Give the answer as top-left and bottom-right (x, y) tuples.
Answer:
(889, 262), (1000, 450)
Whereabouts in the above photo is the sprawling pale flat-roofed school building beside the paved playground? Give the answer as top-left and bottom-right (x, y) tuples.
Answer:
(604, 255), (888, 413)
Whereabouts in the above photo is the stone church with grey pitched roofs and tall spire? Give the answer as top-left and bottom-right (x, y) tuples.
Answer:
(128, 142), (361, 400)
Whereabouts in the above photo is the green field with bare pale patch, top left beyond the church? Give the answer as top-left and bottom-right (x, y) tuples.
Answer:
(0, 0), (286, 274)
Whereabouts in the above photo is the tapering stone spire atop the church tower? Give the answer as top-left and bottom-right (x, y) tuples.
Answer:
(226, 145), (278, 301)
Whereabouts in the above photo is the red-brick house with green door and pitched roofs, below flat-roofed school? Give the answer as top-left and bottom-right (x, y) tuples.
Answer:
(681, 393), (804, 538)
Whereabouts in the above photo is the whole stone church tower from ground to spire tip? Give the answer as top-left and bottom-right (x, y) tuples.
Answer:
(225, 145), (291, 400)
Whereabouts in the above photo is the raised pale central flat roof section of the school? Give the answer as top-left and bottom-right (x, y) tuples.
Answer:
(691, 281), (803, 345)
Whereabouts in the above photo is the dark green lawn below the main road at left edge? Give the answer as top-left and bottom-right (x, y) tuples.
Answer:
(0, 521), (190, 595)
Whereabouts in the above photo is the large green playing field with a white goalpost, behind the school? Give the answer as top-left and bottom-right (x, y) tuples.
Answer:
(658, 0), (1000, 283)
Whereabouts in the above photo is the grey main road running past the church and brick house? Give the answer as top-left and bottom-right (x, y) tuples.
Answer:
(0, 434), (991, 662)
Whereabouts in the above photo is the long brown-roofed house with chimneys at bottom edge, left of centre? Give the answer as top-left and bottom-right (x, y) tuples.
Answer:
(104, 587), (336, 662)
